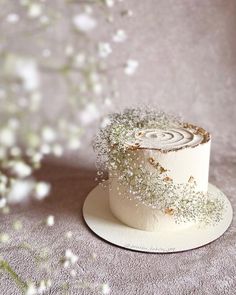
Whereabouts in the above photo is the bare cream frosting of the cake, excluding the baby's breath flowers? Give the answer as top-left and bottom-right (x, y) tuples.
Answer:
(109, 123), (211, 231)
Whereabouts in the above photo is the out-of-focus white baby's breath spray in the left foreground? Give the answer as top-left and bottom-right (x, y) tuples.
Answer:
(0, 0), (138, 295)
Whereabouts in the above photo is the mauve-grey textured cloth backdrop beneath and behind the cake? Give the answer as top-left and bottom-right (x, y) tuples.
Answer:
(0, 0), (236, 295)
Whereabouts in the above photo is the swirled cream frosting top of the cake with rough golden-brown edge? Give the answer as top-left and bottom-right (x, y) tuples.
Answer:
(126, 125), (210, 152)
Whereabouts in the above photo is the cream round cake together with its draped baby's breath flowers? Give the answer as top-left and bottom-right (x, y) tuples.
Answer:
(94, 110), (222, 232)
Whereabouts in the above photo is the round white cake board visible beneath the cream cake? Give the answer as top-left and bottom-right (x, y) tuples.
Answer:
(83, 184), (233, 253)
